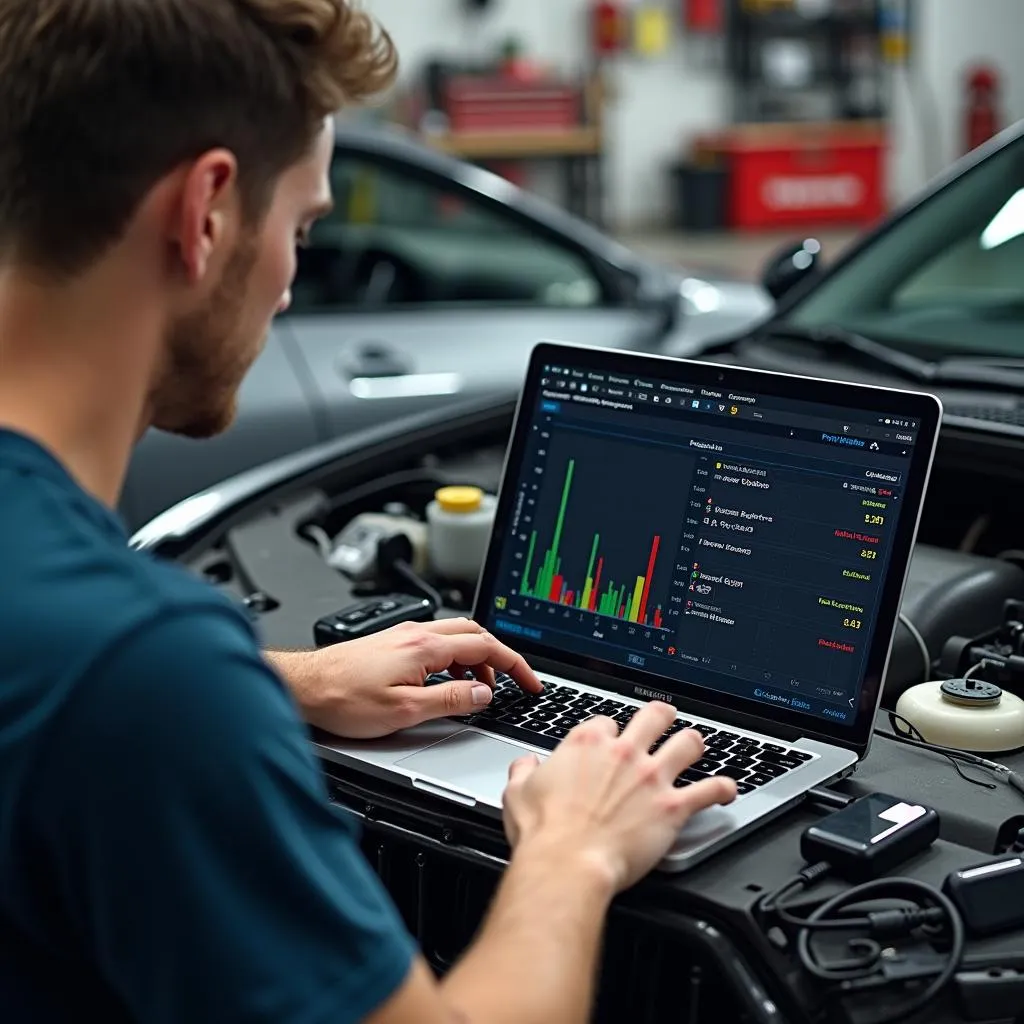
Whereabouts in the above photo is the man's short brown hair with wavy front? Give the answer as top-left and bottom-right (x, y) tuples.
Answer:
(0, 0), (395, 275)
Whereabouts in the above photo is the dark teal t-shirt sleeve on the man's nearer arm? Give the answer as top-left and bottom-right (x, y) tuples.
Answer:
(37, 609), (414, 1024)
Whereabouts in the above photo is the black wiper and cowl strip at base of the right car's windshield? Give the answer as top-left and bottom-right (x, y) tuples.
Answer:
(700, 321), (1024, 392)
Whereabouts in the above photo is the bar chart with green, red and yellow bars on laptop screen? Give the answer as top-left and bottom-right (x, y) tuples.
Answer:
(518, 423), (694, 630)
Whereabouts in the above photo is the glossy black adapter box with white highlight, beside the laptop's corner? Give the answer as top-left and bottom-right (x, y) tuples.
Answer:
(800, 793), (939, 882)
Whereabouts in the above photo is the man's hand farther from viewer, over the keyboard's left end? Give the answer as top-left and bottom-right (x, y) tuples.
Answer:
(267, 618), (542, 739)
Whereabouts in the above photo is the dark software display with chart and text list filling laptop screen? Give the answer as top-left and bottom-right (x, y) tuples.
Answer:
(486, 366), (919, 724)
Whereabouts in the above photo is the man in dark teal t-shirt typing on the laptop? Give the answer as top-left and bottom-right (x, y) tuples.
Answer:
(0, 0), (735, 1024)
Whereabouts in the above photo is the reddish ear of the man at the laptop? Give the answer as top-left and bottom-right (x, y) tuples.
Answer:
(171, 150), (238, 284)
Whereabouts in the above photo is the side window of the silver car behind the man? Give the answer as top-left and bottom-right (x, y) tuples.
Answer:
(292, 154), (603, 312)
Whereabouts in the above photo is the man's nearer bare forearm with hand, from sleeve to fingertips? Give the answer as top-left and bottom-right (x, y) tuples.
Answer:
(367, 705), (735, 1024)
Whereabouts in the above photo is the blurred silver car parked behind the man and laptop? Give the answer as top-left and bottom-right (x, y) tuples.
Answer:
(121, 125), (771, 527)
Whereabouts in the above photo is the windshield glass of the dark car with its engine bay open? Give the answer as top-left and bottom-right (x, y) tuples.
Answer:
(784, 130), (1024, 357)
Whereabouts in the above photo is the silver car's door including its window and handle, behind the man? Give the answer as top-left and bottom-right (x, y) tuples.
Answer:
(279, 147), (664, 434)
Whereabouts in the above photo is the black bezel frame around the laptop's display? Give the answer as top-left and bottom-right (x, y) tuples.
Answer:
(473, 342), (942, 756)
